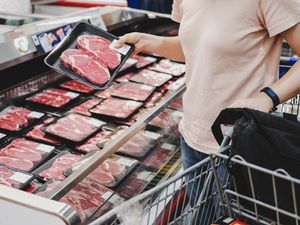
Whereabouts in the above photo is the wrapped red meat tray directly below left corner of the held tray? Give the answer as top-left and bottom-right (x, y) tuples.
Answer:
(27, 88), (79, 108)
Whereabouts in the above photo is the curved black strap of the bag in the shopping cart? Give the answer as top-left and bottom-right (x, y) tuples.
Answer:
(211, 108), (251, 145)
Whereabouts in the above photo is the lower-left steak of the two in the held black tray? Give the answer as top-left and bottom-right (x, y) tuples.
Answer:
(60, 49), (110, 85)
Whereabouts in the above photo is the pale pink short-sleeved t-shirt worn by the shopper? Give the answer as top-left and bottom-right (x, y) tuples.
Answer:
(172, 0), (300, 153)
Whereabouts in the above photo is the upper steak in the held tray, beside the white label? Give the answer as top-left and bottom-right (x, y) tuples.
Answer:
(77, 35), (121, 69)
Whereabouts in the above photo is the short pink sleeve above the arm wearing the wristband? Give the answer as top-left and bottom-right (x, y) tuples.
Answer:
(260, 0), (300, 37)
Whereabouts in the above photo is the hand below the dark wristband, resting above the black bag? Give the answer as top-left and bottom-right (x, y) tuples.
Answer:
(229, 92), (273, 112)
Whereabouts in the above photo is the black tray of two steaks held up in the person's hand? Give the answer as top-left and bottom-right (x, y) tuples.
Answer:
(45, 22), (134, 89)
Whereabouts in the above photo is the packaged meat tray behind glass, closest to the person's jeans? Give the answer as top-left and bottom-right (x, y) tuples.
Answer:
(141, 143), (177, 171)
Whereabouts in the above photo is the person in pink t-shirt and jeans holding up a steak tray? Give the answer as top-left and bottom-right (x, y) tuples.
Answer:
(116, 0), (300, 210)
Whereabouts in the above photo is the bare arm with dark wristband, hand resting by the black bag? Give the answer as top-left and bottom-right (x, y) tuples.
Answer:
(230, 23), (300, 112)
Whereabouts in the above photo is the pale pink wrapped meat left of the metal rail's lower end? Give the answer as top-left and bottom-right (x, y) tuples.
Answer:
(39, 153), (81, 180)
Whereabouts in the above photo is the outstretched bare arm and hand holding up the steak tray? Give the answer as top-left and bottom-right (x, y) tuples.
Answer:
(115, 32), (185, 62)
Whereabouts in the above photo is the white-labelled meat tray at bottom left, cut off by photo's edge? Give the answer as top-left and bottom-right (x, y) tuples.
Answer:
(0, 166), (34, 189)
